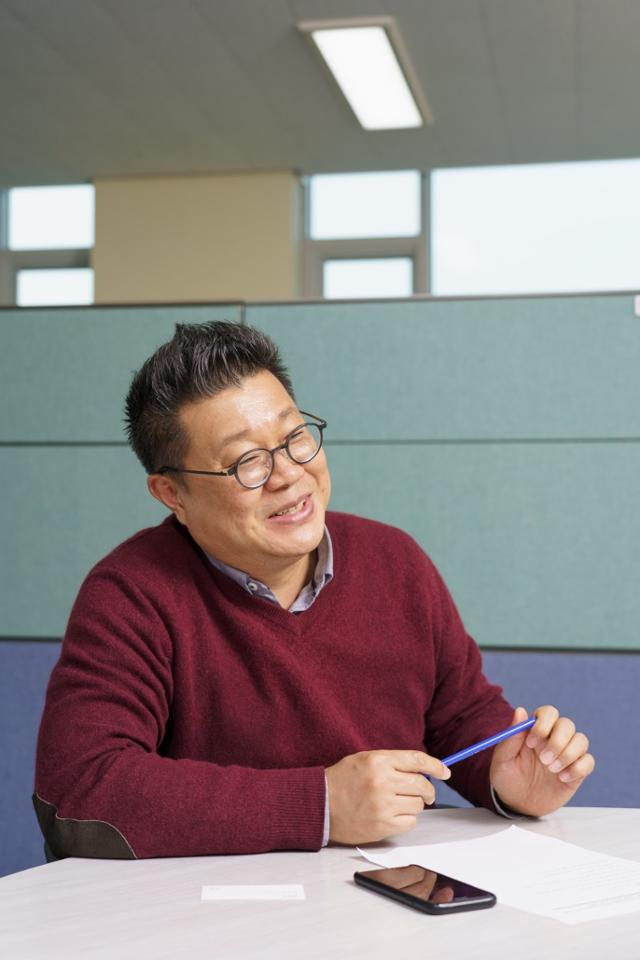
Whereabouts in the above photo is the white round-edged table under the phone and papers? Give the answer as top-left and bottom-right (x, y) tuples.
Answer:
(0, 807), (640, 960)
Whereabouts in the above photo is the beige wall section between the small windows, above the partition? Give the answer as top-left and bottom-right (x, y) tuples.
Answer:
(92, 172), (302, 303)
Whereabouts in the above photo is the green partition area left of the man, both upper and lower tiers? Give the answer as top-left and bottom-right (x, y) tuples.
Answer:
(0, 303), (243, 637)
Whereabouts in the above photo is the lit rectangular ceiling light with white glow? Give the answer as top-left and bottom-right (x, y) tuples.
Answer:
(298, 17), (433, 130)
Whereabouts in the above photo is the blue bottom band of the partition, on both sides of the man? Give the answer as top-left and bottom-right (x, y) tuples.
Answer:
(0, 641), (640, 875)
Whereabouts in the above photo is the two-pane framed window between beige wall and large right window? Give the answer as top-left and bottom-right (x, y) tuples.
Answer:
(303, 170), (426, 299)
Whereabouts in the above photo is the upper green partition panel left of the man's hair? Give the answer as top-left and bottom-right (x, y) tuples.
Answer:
(0, 304), (242, 443)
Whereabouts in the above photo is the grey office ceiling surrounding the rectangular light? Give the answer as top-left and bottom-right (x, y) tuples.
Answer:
(0, 0), (640, 187)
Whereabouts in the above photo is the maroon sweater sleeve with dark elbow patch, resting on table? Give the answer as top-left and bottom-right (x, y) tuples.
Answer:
(34, 567), (325, 857)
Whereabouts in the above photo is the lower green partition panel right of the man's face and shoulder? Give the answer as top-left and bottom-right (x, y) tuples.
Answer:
(327, 444), (640, 650)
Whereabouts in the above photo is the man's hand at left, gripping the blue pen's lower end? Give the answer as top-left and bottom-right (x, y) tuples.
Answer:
(326, 750), (451, 844)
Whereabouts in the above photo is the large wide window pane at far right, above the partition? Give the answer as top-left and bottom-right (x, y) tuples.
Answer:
(431, 160), (640, 295)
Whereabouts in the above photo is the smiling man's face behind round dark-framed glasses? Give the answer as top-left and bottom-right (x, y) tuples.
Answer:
(150, 371), (331, 579)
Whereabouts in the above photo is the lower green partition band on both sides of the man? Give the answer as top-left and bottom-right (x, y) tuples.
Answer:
(5, 443), (640, 650)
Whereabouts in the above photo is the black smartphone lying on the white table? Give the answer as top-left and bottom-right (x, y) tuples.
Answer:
(353, 864), (496, 915)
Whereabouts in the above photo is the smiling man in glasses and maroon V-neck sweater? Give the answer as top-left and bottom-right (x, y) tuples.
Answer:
(34, 323), (594, 857)
